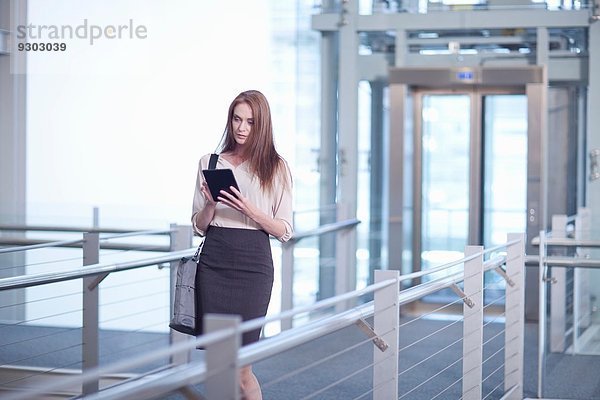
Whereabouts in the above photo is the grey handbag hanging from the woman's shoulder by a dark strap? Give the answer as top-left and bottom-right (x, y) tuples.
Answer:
(169, 154), (219, 336)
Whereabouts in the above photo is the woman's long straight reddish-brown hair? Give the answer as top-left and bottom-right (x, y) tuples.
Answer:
(220, 90), (289, 190)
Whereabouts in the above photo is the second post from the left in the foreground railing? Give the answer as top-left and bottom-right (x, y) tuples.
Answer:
(373, 270), (400, 400)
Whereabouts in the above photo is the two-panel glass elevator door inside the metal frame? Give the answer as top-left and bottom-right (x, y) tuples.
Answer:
(414, 89), (527, 302)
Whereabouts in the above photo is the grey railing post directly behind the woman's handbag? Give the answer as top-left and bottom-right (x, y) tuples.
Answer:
(169, 224), (193, 365)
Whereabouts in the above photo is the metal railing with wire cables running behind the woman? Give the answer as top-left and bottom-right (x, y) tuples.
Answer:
(0, 219), (359, 394)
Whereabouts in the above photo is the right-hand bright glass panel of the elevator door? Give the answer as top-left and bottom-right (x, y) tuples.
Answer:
(483, 94), (527, 302)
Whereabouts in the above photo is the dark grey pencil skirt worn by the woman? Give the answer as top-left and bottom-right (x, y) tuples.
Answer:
(196, 226), (273, 345)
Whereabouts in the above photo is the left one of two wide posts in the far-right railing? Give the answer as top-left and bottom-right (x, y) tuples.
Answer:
(550, 215), (567, 353)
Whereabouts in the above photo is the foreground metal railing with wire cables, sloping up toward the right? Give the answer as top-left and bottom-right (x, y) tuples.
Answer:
(1, 234), (525, 400)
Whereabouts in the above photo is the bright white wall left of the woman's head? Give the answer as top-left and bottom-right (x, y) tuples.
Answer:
(27, 0), (271, 227)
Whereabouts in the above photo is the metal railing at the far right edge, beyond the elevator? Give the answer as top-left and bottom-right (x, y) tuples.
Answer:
(533, 208), (600, 397)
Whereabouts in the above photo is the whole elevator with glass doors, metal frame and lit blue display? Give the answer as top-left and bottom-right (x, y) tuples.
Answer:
(387, 66), (548, 302)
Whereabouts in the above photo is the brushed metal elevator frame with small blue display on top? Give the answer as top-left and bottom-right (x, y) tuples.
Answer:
(387, 66), (547, 278)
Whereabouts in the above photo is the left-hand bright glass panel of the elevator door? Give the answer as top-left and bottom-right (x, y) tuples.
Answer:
(421, 94), (471, 281)
